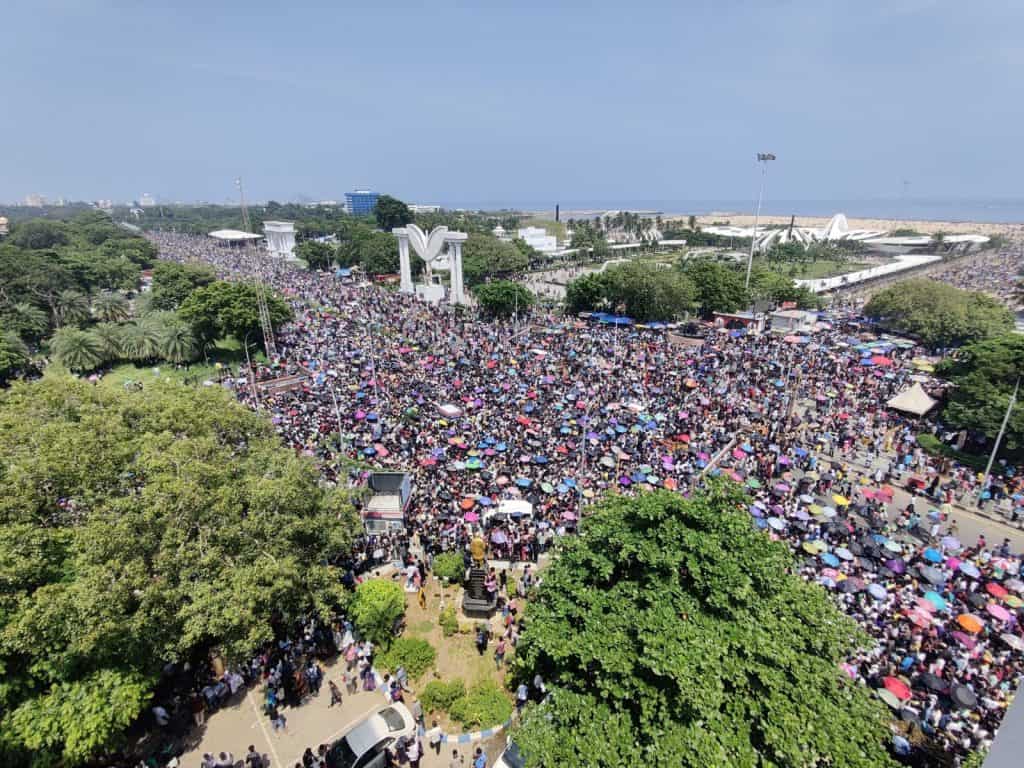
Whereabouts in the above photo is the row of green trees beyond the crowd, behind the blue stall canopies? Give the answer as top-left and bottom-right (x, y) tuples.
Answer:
(565, 258), (818, 322)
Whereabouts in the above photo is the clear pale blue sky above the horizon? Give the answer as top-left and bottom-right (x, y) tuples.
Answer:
(0, 0), (1024, 206)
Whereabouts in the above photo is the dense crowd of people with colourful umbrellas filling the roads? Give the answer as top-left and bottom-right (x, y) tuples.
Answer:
(146, 233), (1024, 765)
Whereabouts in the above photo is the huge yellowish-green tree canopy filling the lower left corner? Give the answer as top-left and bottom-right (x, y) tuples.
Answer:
(0, 378), (358, 766)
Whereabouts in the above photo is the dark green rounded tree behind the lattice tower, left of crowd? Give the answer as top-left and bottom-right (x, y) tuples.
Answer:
(178, 281), (292, 344)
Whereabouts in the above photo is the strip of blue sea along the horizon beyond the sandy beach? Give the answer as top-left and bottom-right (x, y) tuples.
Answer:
(444, 198), (1024, 224)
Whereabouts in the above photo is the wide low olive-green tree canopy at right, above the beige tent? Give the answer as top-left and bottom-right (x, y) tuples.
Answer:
(864, 278), (1014, 349)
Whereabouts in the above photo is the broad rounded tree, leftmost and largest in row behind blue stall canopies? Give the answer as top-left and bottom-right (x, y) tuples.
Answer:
(565, 262), (694, 322)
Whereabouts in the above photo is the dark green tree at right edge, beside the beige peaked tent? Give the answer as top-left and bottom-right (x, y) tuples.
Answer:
(936, 334), (1024, 451)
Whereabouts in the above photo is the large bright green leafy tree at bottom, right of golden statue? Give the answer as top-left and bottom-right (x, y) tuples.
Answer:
(513, 484), (892, 768)
